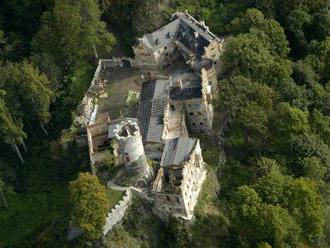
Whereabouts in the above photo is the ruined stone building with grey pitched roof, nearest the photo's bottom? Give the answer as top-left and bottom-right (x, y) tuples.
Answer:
(152, 138), (206, 220)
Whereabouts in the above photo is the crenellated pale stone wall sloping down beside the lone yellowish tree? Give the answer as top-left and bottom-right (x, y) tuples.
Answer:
(102, 189), (132, 235)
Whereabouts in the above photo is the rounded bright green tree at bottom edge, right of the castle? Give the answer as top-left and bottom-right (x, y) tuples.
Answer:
(231, 186), (300, 248)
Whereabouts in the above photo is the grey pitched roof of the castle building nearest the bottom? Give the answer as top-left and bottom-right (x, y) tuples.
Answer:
(161, 137), (198, 167)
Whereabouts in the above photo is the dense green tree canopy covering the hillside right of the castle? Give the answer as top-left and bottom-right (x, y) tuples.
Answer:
(219, 5), (330, 247)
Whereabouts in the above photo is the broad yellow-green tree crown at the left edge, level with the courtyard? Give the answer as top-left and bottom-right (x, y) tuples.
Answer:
(0, 60), (53, 128)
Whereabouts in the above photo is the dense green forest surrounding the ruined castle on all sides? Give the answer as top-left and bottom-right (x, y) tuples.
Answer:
(0, 0), (330, 248)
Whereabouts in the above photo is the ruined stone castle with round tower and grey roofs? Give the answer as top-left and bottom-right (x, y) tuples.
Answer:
(80, 13), (223, 229)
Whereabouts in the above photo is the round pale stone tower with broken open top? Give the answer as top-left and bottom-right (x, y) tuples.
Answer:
(113, 120), (151, 178)
